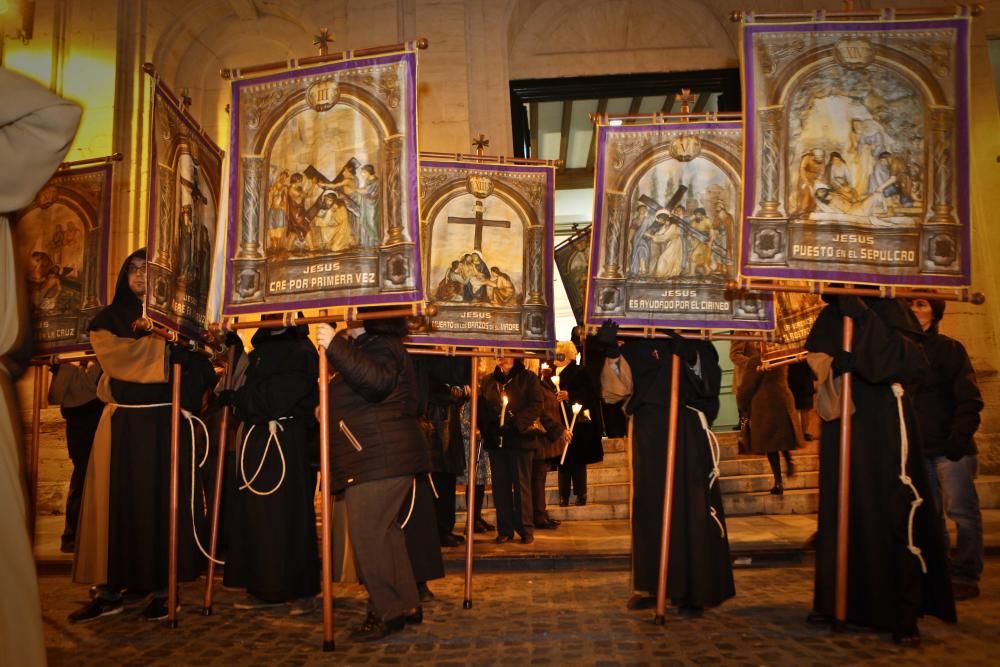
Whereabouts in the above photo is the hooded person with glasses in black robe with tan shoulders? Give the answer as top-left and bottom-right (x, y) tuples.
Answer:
(71, 249), (215, 620)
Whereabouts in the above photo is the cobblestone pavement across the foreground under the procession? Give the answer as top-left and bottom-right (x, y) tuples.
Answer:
(41, 558), (1000, 667)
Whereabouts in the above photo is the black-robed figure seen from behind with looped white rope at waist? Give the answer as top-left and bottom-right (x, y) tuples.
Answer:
(220, 325), (319, 603)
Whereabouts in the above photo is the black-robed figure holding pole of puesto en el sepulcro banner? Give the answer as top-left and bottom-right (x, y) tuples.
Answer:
(806, 296), (956, 642)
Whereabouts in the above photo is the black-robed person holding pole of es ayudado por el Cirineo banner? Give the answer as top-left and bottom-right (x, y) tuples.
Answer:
(598, 323), (736, 615)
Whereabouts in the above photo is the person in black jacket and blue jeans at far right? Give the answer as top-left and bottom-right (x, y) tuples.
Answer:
(909, 299), (983, 600)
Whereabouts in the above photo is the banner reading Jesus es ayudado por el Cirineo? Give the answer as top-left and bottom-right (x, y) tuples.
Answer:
(586, 122), (774, 330)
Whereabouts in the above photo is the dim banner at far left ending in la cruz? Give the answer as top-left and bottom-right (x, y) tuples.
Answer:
(14, 164), (111, 354)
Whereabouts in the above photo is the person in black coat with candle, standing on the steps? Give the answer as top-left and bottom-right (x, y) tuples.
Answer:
(559, 327), (604, 507)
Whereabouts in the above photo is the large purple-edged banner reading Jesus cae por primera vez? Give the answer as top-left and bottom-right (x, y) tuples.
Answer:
(222, 52), (423, 315)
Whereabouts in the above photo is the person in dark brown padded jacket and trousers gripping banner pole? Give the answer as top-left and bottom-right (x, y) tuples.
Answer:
(316, 318), (431, 641)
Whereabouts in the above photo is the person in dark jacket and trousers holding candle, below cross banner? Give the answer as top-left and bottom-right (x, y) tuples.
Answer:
(477, 357), (545, 544)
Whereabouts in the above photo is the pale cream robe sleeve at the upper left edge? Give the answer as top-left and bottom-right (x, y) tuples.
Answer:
(0, 67), (81, 211)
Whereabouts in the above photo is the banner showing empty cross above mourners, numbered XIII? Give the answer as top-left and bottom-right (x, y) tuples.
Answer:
(410, 159), (555, 350)
